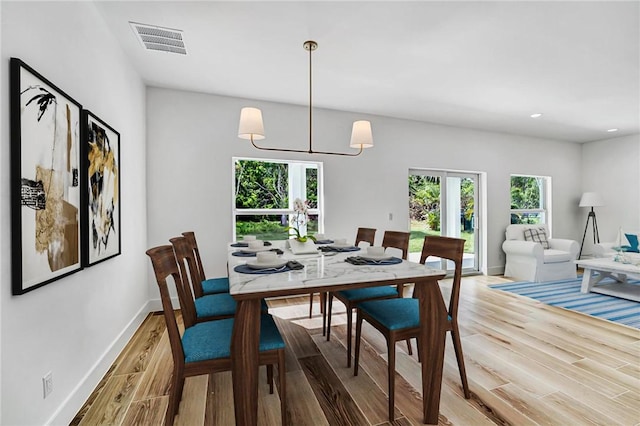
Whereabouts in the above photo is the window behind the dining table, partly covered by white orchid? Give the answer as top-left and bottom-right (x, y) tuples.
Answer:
(232, 158), (323, 240)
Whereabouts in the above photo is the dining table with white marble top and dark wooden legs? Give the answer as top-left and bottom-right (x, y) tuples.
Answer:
(227, 241), (448, 426)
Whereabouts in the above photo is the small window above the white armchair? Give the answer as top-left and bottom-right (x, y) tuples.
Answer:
(511, 175), (551, 224)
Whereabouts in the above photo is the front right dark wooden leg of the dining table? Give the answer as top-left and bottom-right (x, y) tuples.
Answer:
(414, 278), (448, 425)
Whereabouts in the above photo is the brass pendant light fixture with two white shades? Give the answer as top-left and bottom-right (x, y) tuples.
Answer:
(238, 40), (373, 157)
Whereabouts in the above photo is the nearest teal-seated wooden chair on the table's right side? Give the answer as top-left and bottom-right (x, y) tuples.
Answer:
(353, 236), (471, 422)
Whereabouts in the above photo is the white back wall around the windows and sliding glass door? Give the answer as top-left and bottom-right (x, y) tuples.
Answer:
(147, 88), (582, 286)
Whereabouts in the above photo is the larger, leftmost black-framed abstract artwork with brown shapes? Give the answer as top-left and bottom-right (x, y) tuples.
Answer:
(9, 58), (82, 295)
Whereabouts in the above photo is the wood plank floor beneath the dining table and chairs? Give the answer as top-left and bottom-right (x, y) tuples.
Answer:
(72, 276), (640, 426)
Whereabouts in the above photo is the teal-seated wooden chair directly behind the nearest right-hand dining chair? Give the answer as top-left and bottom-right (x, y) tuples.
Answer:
(327, 231), (411, 367)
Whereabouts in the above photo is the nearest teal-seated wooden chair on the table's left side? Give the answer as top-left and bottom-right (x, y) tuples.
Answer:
(147, 245), (287, 426)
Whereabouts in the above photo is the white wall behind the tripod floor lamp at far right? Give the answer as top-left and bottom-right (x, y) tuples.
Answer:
(578, 134), (640, 254)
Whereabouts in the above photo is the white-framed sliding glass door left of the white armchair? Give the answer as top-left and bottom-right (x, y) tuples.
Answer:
(409, 169), (479, 272)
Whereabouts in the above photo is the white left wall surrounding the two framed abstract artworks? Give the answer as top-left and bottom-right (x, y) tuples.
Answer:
(0, 1), (149, 425)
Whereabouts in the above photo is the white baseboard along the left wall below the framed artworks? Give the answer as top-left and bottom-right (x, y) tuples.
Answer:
(45, 299), (154, 425)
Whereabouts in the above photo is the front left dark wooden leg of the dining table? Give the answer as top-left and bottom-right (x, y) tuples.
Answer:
(231, 299), (260, 426)
